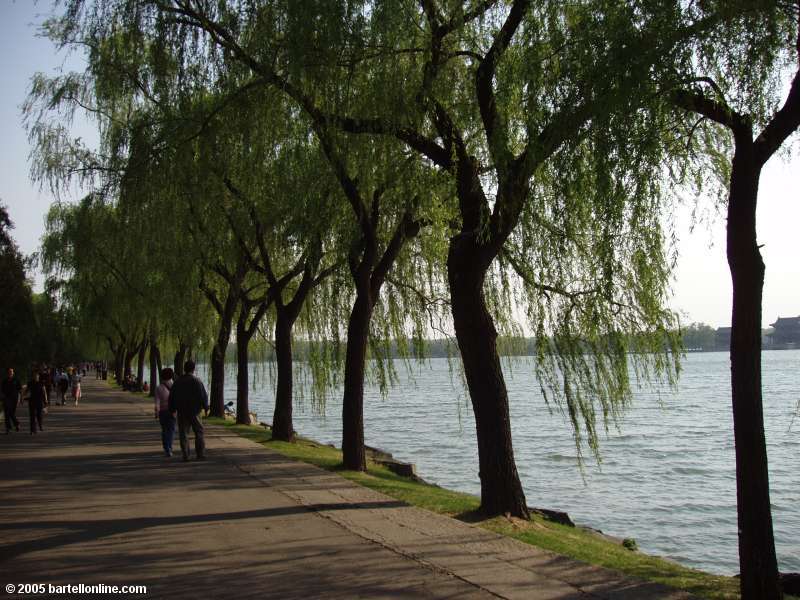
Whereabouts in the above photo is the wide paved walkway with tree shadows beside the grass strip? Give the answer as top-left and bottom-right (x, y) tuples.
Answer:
(0, 378), (689, 600)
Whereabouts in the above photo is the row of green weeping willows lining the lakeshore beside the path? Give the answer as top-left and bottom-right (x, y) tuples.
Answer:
(26, 0), (800, 598)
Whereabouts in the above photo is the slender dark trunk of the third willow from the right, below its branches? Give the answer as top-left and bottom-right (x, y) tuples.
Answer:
(342, 286), (374, 471)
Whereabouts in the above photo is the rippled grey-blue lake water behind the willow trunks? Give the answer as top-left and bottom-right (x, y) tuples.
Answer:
(184, 350), (800, 574)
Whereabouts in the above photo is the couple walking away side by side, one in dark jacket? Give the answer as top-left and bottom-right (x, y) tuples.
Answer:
(155, 360), (208, 461)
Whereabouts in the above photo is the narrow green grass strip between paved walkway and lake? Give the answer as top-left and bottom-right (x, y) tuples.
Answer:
(207, 418), (788, 600)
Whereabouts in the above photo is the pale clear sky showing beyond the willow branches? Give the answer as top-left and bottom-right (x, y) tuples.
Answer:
(0, 0), (800, 327)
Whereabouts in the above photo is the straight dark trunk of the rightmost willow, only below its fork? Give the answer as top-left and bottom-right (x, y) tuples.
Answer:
(727, 136), (782, 600)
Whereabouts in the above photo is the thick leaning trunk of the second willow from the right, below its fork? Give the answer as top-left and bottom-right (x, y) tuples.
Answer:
(447, 233), (530, 518)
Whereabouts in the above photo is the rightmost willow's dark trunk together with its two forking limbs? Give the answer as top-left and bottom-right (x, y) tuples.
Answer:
(673, 72), (800, 600)
